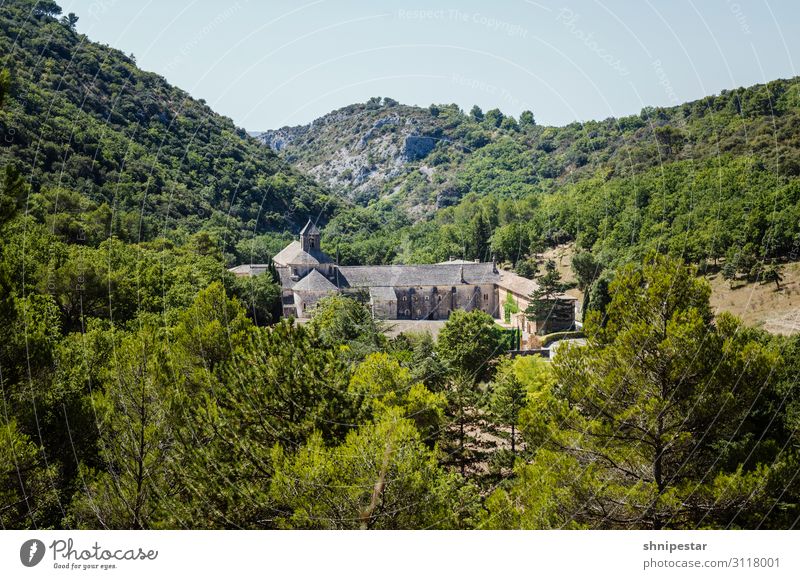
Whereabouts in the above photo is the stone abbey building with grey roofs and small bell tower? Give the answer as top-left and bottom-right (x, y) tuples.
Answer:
(231, 221), (575, 333)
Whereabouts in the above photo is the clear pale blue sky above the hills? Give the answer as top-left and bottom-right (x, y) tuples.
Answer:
(60, 0), (800, 131)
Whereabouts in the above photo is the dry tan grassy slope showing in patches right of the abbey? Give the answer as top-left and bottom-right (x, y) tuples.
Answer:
(541, 244), (800, 334)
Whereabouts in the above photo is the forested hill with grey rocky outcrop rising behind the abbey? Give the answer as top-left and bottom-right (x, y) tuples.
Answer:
(260, 78), (800, 274)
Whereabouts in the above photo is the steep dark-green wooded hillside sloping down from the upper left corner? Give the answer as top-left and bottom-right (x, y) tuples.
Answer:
(0, 0), (333, 260)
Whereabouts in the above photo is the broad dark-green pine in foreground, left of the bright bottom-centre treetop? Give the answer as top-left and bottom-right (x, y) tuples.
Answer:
(165, 320), (356, 529)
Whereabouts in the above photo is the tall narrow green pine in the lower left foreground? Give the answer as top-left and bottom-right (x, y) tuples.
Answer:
(71, 327), (177, 529)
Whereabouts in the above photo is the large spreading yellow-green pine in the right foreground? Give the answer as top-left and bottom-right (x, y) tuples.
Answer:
(506, 257), (777, 528)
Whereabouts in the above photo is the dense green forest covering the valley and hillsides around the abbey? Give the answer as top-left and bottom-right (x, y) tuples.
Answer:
(0, 0), (800, 529)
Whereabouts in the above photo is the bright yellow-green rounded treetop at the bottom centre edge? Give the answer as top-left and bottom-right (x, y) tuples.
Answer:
(270, 412), (477, 529)
